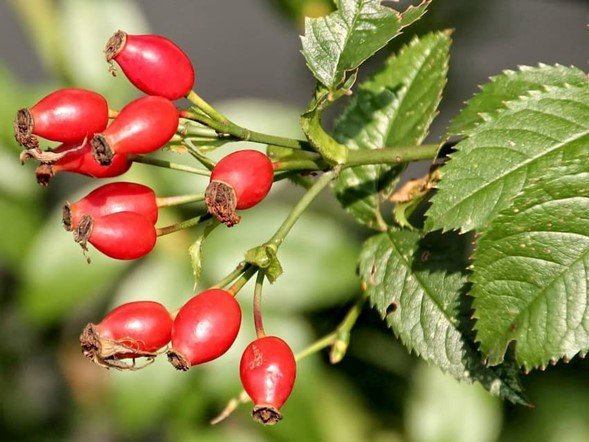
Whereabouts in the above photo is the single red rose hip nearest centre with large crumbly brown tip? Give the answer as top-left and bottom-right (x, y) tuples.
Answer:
(205, 150), (274, 227)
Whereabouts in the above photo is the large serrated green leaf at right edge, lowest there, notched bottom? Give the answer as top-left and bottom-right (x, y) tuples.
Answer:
(472, 157), (589, 370)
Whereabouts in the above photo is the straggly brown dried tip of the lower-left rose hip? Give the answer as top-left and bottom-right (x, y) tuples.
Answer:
(80, 324), (157, 370)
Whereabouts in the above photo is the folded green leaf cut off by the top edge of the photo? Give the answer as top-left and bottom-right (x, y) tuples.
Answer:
(301, 0), (431, 91)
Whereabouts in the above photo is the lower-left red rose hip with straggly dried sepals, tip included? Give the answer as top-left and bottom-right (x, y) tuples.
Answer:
(80, 301), (173, 370)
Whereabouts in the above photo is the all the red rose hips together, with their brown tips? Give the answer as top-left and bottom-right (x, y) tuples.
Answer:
(14, 31), (296, 424)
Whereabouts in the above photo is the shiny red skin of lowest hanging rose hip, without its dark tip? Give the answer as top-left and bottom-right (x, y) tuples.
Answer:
(239, 336), (296, 409)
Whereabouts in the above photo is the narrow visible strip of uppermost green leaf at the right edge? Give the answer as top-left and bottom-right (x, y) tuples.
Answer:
(447, 64), (587, 136)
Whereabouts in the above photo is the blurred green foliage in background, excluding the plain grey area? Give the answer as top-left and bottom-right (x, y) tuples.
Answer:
(0, 0), (589, 442)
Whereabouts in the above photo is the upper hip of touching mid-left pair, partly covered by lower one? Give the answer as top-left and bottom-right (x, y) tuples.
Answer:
(67, 182), (158, 230)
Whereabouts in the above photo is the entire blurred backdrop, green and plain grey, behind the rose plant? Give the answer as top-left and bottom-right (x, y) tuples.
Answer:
(0, 0), (589, 442)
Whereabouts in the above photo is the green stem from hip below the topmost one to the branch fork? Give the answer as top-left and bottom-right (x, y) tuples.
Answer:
(182, 112), (315, 152)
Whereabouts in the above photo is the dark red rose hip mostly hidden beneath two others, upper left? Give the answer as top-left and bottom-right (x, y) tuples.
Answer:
(35, 141), (133, 186)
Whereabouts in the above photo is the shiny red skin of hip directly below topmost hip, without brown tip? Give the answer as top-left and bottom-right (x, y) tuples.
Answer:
(95, 96), (178, 158)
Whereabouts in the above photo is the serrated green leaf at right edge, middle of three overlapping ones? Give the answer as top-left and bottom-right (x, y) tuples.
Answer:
(425, 83), (589, 231)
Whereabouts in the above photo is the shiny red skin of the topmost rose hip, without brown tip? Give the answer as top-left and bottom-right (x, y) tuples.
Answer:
(113, 31), (194, 100)
